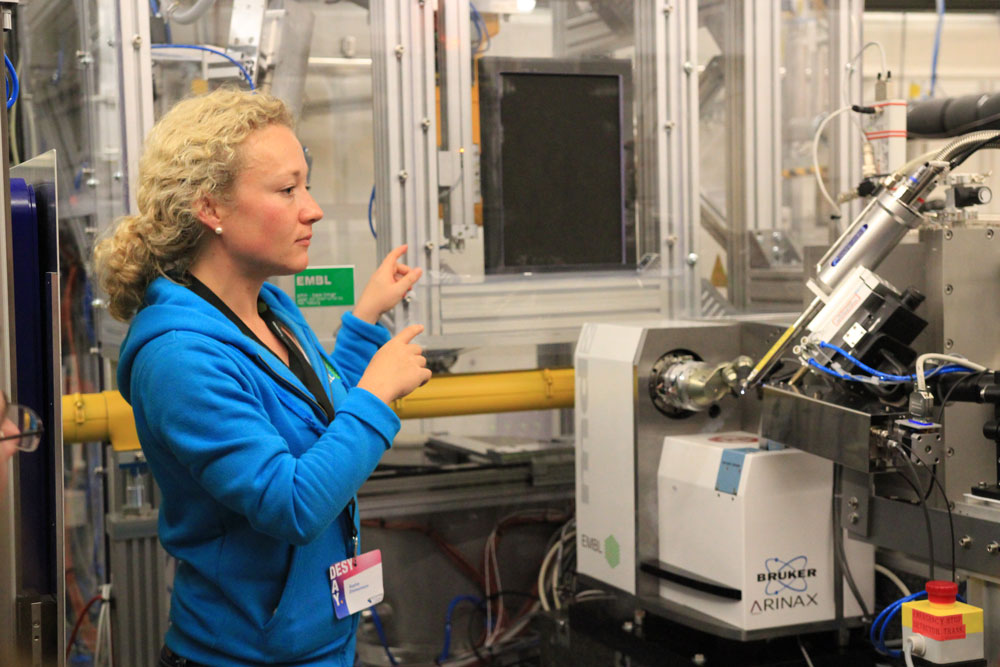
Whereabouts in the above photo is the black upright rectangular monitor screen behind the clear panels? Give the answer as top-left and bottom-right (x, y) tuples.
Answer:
(480, 59), (635, 273)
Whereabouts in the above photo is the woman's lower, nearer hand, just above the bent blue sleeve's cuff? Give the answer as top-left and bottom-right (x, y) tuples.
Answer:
(358, 324), (431, 405)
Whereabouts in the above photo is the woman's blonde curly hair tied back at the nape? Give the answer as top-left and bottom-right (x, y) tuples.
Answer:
(94, 88), (292, 321)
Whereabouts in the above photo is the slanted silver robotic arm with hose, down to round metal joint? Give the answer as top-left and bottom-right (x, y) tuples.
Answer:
(650, 131), (1000, 414)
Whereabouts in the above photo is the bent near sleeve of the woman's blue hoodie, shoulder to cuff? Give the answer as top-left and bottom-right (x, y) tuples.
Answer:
(132, 334), (400, 544)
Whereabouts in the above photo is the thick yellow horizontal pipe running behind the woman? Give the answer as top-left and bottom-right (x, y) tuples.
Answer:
(63, 368), (575, 451)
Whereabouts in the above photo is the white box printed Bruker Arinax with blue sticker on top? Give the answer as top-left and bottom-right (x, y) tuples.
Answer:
(658, 432), (874, 630)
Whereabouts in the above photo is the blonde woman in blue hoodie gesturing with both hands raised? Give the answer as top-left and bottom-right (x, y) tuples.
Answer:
(95, 90), (430, 666)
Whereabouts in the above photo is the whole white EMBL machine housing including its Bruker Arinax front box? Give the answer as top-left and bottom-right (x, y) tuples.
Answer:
(574, 320), (874, 641)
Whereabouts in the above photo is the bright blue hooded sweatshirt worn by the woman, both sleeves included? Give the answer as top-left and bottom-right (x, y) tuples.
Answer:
(118, 278), (400, 665)
